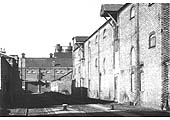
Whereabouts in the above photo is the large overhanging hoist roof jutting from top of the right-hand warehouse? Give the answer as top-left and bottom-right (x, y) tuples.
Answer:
(100, 4), (123, 18)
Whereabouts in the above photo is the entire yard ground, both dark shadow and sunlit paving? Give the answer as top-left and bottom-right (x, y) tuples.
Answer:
(2, 93), (170, 117)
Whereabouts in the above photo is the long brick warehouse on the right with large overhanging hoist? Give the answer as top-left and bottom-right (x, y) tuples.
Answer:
(73, 3), (170, 109)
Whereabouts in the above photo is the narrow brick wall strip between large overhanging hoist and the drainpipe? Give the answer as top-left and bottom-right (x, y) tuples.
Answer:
(118, 4), (137, 103)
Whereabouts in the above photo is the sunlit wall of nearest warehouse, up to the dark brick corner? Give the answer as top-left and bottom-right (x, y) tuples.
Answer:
(119, 3), (169, 108)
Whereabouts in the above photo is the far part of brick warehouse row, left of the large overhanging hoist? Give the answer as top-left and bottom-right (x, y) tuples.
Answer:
(73, 19), (118, 100)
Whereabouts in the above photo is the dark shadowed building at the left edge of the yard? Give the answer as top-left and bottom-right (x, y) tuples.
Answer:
(0, 53), (22, 108)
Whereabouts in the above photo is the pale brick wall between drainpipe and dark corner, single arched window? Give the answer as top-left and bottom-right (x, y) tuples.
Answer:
(139, 3), (161, 108)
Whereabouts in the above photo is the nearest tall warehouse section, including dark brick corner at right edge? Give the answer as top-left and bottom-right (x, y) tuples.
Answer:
(101, 3), (170, 108)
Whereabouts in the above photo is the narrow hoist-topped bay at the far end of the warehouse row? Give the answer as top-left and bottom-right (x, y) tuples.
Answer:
(72, 36), (88, 97)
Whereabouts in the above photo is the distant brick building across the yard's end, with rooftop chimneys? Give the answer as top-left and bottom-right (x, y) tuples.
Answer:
(20, 44), (72, 93)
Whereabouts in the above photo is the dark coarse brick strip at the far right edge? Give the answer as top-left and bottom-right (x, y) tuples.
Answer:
(161, 3), (170, 109)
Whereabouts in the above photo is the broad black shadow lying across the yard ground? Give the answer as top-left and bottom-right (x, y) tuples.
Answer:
(11, 92), (113, 108)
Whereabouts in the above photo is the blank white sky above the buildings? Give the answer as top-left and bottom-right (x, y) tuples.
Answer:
(0, 0), (165, 57)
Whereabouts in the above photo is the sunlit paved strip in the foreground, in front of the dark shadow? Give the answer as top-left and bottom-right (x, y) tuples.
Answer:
(10, 104), (170, 117)
